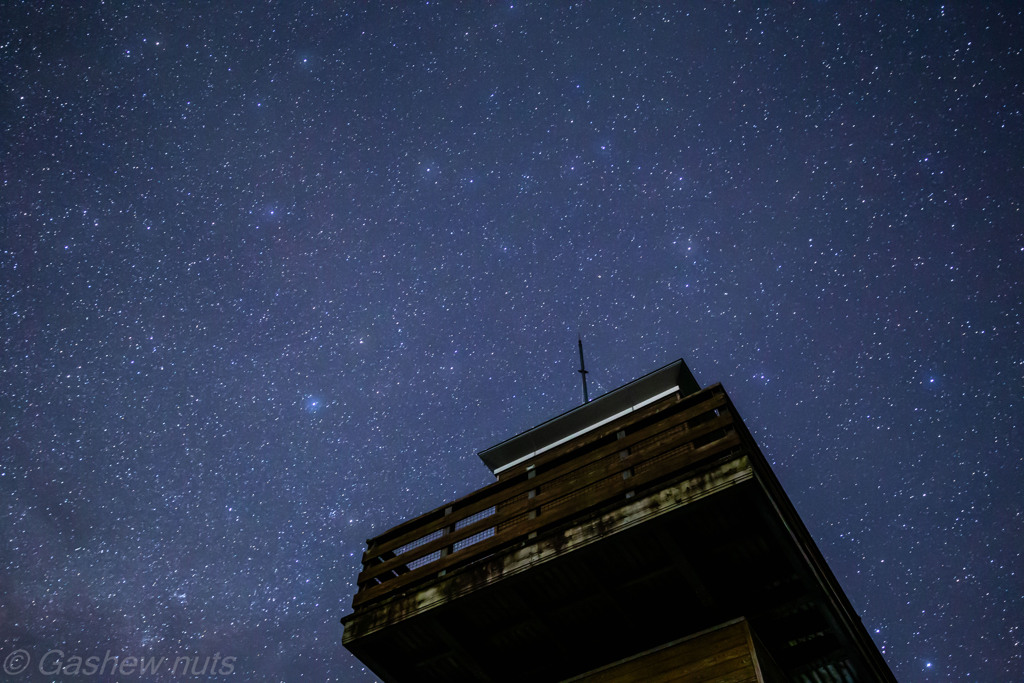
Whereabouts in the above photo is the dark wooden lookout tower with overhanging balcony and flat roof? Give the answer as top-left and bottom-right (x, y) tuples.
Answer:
(342, 360), (895, 683)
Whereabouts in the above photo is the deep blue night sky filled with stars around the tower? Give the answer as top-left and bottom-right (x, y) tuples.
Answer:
(0, 0), (1024, 682)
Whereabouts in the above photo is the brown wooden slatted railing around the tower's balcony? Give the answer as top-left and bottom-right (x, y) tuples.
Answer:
(352, 385), (740, 609)
